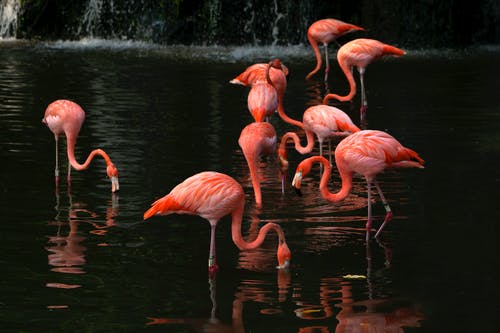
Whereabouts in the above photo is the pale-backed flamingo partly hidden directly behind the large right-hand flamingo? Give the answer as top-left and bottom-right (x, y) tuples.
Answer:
(278, 104), (360, 169)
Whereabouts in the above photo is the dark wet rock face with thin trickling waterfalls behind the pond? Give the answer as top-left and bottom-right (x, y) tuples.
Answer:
(6, 0), (500, 48)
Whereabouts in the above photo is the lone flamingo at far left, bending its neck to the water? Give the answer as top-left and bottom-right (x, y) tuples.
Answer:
(42, 99), (120, 192)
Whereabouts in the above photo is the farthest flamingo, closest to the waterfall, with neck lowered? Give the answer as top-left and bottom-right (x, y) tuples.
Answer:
(306, 18), (365, 82)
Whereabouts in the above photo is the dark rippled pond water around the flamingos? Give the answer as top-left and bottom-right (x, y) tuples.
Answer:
(0, 42), (500, 332)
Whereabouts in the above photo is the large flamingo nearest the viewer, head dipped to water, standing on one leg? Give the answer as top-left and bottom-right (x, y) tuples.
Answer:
(144, 171), (291, 274)
